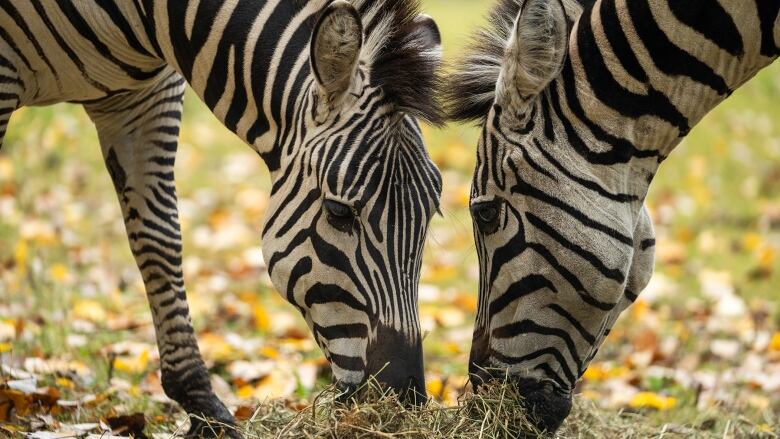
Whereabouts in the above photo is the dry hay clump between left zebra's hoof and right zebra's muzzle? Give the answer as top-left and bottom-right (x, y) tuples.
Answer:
(242, 383), (539, 439)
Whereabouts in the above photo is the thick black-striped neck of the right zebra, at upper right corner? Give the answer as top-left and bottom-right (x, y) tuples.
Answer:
(557, 0), (780, 165)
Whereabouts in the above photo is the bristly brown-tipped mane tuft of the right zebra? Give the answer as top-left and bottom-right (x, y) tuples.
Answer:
(444, 0), (522, 122)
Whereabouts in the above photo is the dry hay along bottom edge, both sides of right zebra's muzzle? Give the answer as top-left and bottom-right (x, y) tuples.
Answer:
(184, 385), (780, 439)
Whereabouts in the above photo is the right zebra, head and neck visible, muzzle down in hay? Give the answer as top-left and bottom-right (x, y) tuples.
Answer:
(445, 0), (780, 431)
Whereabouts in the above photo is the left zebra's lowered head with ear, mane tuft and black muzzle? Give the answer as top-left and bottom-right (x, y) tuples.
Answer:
(263, 0), (442, 399)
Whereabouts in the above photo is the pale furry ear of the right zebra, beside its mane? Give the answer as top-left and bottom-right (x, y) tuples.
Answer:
(496, 0), (569, 117)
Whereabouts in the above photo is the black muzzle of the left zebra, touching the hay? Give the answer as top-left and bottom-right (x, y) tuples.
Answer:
(337, 325), (428, 406)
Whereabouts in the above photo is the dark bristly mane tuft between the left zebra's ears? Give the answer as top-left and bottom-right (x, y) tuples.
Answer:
(352, 0), (445, 125)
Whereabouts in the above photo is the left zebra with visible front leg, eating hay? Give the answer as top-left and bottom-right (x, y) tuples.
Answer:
(0, 0), (444, 436)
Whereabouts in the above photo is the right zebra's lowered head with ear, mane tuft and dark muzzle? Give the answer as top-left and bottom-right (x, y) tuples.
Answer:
(447, 0), (657, 430)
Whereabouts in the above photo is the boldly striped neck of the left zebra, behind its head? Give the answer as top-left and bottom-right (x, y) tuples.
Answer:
(143, 0), (327, 166)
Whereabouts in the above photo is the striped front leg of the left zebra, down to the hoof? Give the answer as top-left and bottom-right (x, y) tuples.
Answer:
(87, 73), (237, 437)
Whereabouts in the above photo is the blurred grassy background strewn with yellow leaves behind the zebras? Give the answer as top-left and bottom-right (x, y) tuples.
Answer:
(0, 0), (780, 433)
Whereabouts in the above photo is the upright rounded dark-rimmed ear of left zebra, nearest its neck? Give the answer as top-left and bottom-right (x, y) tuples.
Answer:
(309, 0), (363, 113)
